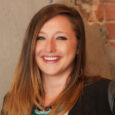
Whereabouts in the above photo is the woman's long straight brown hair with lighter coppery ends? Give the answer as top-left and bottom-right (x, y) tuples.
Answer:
(1, 4), (85, 115)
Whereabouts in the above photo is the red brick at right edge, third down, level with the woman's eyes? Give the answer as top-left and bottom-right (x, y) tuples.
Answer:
(105, 23), (115, 39)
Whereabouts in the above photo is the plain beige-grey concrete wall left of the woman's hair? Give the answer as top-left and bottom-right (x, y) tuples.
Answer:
(0, 0), (67, 109)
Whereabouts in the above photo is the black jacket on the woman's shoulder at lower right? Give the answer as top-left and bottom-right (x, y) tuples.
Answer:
(68, 79), (115, 115)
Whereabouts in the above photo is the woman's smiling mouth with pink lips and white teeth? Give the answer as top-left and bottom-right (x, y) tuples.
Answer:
(41, 56), (61, 63)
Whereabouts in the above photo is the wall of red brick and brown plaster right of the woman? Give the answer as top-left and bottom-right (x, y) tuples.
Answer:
(71, 0), (115, 80)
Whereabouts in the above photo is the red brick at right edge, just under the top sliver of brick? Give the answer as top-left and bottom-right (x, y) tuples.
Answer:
(105, 4), (115, 21)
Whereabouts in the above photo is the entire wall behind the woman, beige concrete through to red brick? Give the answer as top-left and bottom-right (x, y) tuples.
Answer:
(0, 0), (115, 110)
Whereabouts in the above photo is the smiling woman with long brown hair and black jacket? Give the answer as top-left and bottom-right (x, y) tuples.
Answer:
(1, 4), (115, 115)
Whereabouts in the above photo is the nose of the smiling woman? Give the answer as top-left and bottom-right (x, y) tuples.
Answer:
(45, 39), (56, 53)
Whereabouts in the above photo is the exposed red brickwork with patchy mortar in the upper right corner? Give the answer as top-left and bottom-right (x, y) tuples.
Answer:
(75, 0), (115, 49)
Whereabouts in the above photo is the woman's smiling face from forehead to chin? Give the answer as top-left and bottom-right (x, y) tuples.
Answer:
(35, 15), (77, 76)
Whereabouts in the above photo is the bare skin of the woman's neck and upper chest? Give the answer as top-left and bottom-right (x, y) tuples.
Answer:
(43, 74), (70, 106)
